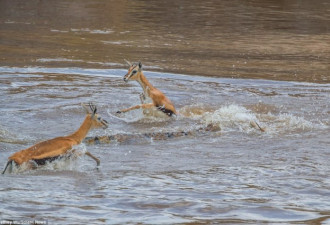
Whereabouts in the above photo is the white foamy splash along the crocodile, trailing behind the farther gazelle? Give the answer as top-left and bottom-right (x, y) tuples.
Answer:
(101, 104), (328, 141)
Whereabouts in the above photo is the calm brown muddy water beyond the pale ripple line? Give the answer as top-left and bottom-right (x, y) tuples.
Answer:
(0, 0), (330, 83)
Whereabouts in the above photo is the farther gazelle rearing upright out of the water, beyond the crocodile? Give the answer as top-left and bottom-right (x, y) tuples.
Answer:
(117, 60), (177, 116)
